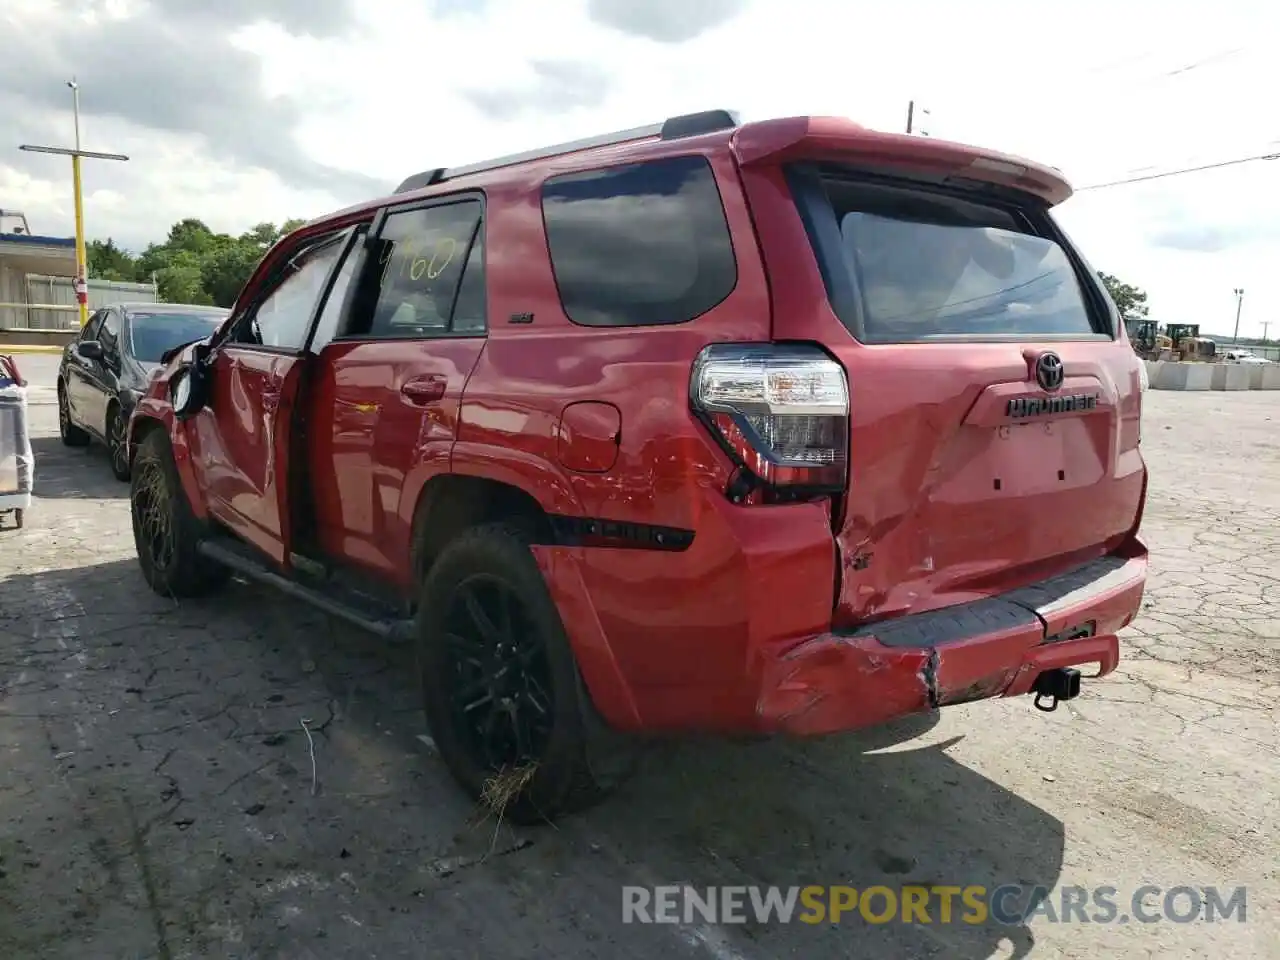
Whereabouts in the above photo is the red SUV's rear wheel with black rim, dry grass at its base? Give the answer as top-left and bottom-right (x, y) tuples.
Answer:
(417, 524), (636, 824)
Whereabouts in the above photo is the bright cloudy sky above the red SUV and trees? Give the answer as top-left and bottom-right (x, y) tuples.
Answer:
(0, 0), (1280, 337)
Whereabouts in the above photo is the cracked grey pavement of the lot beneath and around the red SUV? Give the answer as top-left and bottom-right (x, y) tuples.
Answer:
(0, 366), (1280, 960)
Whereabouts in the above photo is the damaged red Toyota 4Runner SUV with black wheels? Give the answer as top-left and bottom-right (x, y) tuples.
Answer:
(129, 110), (1147, 820)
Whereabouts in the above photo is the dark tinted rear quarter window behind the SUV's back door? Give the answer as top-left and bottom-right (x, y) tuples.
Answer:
(543, 156), (737, 326)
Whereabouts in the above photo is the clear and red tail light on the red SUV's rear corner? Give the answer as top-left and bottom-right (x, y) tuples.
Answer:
(689, 343), (849, 494)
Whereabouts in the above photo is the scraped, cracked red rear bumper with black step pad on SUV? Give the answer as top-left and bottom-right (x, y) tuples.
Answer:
(756, 540), (1147, 736)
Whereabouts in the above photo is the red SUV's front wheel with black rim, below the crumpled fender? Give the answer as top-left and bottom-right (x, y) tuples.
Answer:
(129, 430), (230, 599)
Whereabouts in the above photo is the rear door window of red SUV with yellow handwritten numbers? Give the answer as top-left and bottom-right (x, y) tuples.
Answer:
(367, 200), (483, 338)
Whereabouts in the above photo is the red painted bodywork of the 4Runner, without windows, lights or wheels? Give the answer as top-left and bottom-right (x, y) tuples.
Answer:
(132, 118), (1146, 733)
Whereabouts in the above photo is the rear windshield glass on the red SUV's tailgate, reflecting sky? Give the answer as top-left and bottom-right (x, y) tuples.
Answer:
(824, 179), (1097, 343)
